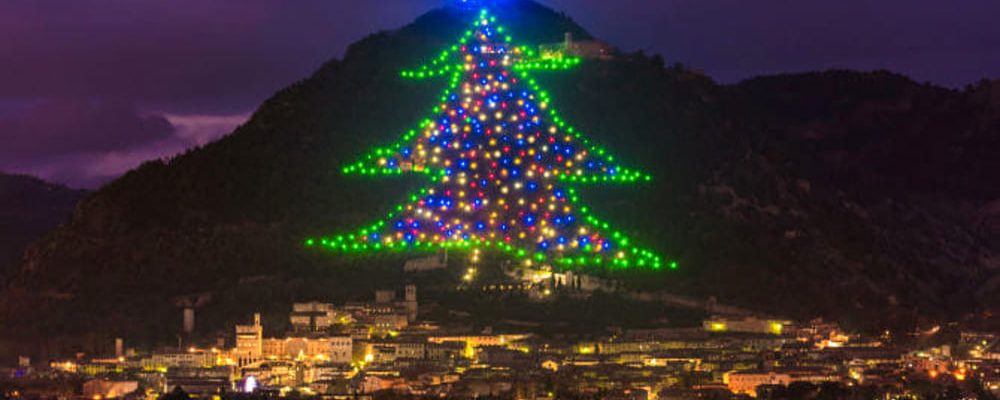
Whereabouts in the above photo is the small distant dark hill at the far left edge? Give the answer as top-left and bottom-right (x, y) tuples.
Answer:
(0, 173), (84, 282)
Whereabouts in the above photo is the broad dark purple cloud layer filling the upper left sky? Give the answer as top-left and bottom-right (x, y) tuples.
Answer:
(0, 0), (439, 113)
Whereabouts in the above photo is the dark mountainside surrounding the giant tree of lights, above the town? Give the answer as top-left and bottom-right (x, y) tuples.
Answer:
(0, 1), (1000, 356)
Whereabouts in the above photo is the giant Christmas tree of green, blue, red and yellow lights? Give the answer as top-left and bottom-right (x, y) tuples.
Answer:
(306, 10), (677, 269)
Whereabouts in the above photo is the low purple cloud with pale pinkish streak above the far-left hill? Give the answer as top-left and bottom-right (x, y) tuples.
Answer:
(0, 99), (247, 187)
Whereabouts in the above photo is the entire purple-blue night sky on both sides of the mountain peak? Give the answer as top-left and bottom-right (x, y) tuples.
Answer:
(0, 0), (1000, 187)
